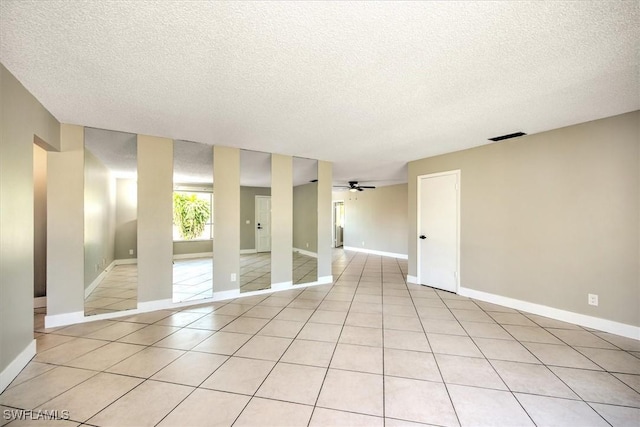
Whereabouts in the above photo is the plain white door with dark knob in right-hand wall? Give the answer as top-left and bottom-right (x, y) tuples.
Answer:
(416, 171), (460, 292)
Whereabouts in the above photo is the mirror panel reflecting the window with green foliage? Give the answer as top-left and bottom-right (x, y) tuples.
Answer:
(173, 140), (213, 302)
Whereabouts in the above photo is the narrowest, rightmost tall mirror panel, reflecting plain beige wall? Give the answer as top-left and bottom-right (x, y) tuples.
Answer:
(293, 157), (318, 285)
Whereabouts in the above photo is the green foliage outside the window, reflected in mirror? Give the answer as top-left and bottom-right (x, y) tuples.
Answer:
(173, 193), (211, 240)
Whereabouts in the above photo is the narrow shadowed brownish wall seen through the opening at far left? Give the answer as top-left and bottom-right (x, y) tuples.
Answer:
(33, 144), (47, 297)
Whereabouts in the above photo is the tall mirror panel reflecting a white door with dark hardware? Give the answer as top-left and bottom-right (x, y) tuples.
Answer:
(240, 150), (271, 292)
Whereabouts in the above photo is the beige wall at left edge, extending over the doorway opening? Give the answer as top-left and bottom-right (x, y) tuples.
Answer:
(0, 64), (60, 382)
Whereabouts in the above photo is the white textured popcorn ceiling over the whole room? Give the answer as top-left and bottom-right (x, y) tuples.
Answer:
(0, 0), (640, 185)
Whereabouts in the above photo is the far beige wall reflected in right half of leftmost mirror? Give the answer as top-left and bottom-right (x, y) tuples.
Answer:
(115, 178), (138, 259)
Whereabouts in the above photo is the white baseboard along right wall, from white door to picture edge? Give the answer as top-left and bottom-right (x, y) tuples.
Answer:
(459, 287), (640, 340)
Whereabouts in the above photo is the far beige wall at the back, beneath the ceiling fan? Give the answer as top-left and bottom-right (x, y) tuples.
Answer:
(333, 184), (409, 255)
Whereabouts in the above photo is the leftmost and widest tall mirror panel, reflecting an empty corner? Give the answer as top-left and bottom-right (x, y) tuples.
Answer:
(84, 128), (138, 316)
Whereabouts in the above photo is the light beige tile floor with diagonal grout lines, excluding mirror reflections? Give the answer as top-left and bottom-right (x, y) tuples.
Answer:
(0, 252), (640, 427)
